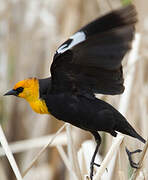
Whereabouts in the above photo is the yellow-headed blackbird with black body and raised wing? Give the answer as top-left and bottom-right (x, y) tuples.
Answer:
(5, 5), (145, 179)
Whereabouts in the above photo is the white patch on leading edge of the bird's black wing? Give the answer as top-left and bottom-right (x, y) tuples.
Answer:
(57, 31), (86, 54)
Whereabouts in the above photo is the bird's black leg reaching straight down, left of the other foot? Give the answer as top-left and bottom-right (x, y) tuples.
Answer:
(90, 132), (101, 180)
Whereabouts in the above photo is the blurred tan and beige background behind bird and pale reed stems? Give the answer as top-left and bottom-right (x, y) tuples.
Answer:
(0, 0), (148, 180)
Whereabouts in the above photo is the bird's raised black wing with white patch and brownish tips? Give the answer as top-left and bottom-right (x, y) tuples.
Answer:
(51, 5), (137, 95)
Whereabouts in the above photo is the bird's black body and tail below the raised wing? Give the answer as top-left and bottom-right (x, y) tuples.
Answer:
(45, 93), (145, 142)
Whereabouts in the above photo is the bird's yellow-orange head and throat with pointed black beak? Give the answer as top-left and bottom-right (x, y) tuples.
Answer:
(4, 78), (49, 114)
